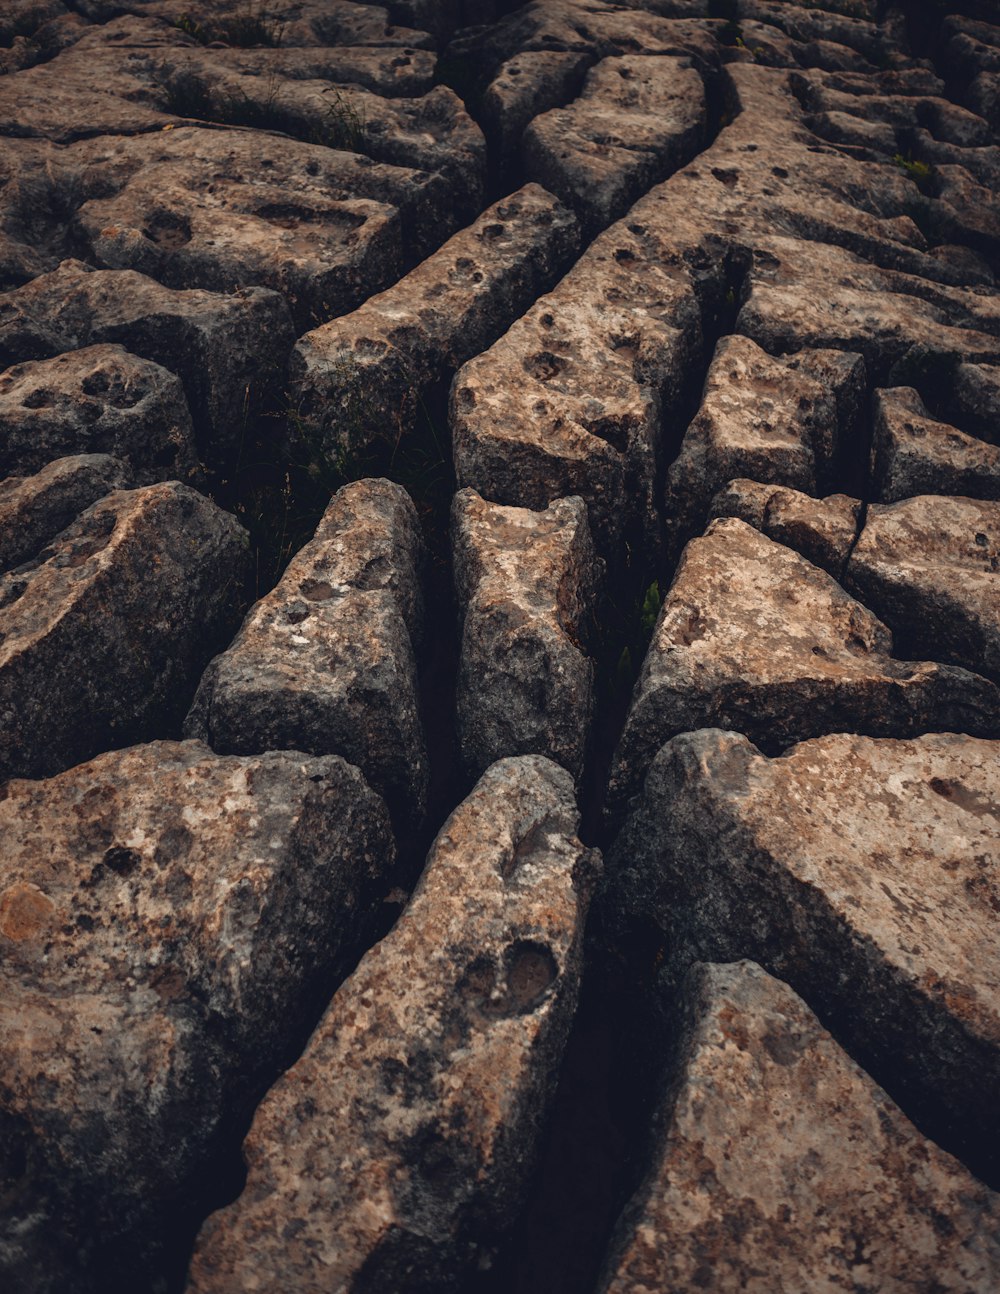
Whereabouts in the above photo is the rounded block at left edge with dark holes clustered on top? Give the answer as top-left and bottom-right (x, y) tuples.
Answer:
(0, 345), (198, 485)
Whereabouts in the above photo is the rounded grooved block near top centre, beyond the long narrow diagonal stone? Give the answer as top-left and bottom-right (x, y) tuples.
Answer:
(523, 54), (708, 233)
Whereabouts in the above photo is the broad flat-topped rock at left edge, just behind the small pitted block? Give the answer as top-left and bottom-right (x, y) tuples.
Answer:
(0, 261), (292, 455)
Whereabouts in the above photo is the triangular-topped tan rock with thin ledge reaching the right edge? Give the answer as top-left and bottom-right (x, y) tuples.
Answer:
(611, 519), (1000, 801)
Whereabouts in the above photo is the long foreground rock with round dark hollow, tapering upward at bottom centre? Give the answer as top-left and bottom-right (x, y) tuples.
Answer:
(189, 756), (596, 1294)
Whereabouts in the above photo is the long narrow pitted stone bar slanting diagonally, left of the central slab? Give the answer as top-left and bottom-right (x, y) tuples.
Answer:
(292, 184), (580, 452)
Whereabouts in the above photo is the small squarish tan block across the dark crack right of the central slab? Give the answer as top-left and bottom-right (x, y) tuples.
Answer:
(666, 336), (864, 545)
